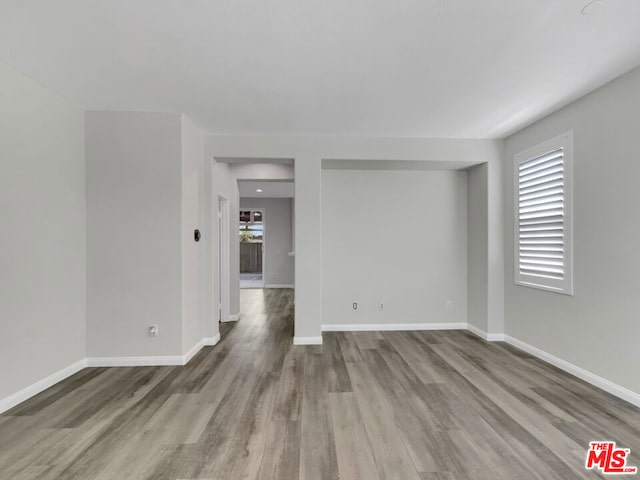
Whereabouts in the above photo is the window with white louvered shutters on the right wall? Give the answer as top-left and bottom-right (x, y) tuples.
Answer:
(514, 132), (573, 295)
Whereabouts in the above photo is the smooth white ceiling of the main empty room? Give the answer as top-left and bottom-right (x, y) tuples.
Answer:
(0, 0), (640, 138)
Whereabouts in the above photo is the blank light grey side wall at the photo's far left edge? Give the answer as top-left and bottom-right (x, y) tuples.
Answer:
(0, 63), (86, 399)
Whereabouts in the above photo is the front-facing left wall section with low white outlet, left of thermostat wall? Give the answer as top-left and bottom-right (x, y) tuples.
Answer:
(86, 112), (183, 357)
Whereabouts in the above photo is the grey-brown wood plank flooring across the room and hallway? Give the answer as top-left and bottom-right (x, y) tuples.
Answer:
(0, 290), (640, 480)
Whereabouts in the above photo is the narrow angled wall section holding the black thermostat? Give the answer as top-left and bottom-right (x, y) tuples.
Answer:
(182, 115), (205, 353)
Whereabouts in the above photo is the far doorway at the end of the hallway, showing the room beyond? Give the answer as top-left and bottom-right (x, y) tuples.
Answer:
(238, 209), (265, 288)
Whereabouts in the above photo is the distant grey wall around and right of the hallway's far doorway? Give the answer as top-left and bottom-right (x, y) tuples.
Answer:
(236, 197), (294, 288)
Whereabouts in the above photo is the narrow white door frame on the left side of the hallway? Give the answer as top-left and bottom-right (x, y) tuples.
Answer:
(216, 194), (231, 322)
